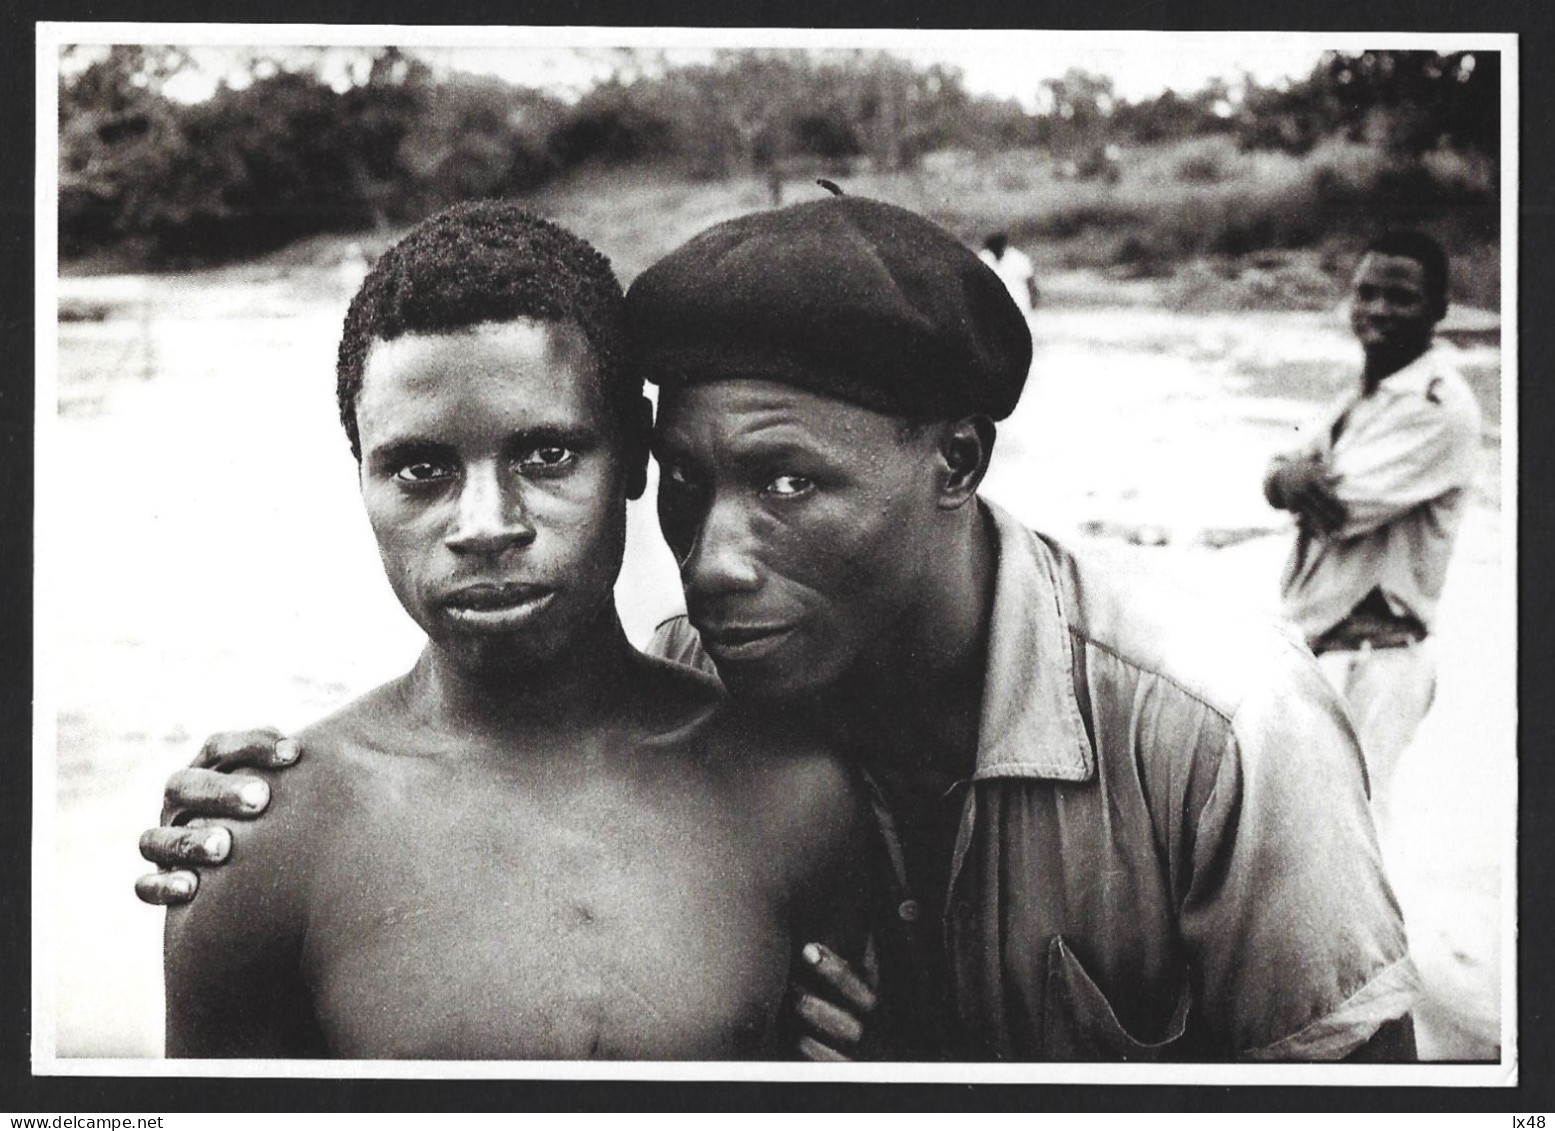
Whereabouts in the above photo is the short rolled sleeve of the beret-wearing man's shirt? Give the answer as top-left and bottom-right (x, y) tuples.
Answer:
(1180, 650), (1417, 1059)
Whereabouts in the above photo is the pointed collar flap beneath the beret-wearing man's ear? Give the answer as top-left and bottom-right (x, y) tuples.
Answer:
(972, 499), (1096, 781)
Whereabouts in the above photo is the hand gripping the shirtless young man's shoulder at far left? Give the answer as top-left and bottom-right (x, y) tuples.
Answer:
(135, 727), (302, 905)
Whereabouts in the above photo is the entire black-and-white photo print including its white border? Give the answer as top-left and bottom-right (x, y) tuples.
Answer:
(31, 23), (1519, 1086)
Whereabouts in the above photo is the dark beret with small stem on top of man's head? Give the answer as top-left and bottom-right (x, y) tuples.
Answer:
(627, 196), (1031, 420)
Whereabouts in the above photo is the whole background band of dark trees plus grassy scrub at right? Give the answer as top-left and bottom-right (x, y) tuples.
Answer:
(59, 47), (1499, 269)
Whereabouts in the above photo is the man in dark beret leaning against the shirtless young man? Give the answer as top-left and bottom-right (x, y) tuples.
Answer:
(139, 198), (1417, 1059)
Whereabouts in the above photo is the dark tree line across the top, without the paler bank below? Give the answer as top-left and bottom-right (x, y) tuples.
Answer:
(59, 47), (1501, 263)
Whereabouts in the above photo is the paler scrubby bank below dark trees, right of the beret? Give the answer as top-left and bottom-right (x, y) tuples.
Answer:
(889, 137), (1499, 305)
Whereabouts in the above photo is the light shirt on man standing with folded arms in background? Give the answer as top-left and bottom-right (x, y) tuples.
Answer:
(1277, 344), (1480, 639)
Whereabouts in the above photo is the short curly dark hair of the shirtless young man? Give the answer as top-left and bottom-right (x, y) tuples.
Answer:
(334, 201), (642, 462)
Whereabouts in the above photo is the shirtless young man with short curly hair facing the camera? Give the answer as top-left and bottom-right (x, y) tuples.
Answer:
(166, 204), (866, 1059)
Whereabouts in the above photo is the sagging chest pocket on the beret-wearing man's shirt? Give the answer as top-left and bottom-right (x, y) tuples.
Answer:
(1042, 935), (1191, 1061)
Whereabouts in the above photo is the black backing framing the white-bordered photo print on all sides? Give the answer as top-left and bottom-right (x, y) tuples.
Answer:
(0, 0), (1555, 1113)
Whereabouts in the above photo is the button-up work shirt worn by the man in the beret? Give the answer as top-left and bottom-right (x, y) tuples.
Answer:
(656, 504), (1418, 1059)
